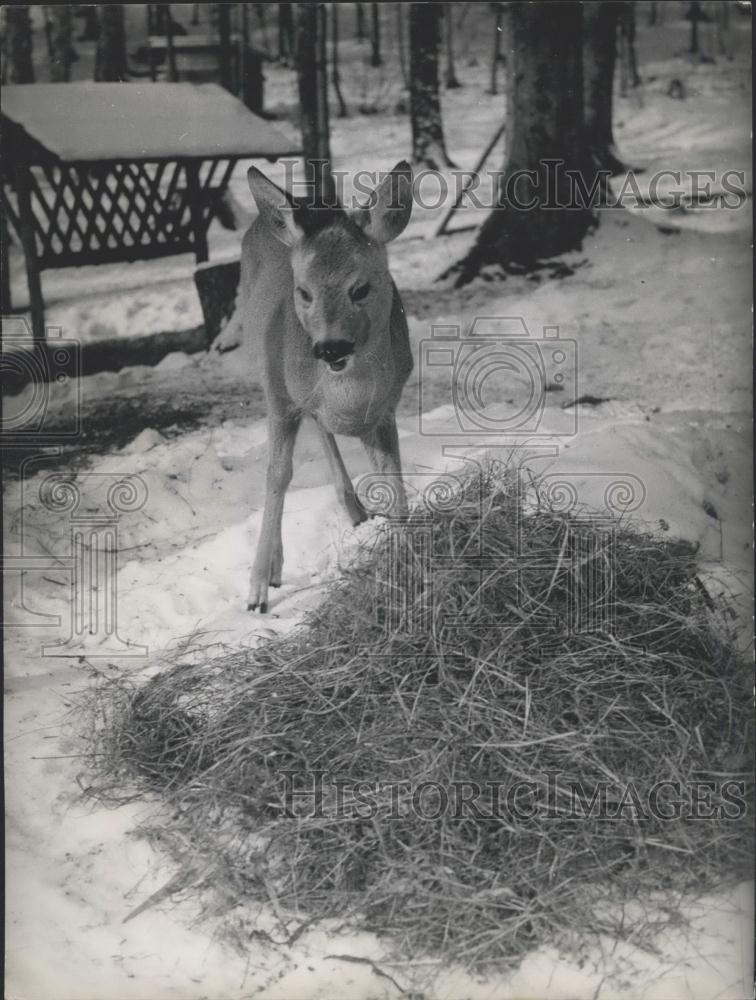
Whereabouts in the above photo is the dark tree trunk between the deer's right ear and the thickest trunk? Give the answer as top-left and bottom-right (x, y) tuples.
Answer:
(409, 3), (454, 170)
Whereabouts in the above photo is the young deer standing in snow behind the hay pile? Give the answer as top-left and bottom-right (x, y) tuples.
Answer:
(230, 161), (413, 614)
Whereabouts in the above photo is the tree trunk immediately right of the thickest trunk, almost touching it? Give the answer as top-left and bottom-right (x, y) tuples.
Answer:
(583, 0), (625, 174)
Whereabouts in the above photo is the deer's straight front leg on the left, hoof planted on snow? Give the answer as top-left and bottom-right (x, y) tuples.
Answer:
(247, 413), (299, 614)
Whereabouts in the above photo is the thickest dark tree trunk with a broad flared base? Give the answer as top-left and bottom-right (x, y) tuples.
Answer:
(447, 0), (596, 286)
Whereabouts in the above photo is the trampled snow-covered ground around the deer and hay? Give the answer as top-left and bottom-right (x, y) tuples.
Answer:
(4, 7), (753, 1000)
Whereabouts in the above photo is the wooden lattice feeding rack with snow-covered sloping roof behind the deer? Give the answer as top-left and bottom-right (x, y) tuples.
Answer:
(0, 83), (299, 342)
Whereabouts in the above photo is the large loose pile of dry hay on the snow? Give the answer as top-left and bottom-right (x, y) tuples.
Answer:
(82, 475), (752, 967)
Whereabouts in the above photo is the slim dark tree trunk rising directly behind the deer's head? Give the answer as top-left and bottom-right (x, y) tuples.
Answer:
(297, 3), (335, 205)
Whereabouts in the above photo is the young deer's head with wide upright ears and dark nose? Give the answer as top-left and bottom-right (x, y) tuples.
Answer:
(247, 161), (412, 373)
